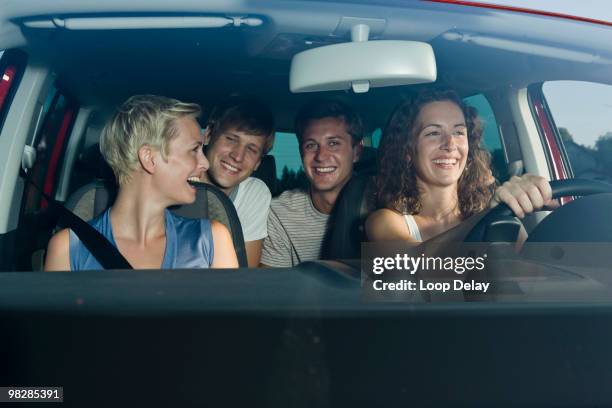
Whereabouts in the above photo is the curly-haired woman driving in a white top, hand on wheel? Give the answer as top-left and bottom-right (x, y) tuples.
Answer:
(366, 89), (554, 242)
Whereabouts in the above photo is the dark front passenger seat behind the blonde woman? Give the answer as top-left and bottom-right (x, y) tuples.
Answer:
(65, 180), (248, 268)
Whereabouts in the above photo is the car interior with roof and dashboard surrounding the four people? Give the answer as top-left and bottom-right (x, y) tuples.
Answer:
(0, 0), (612, 406)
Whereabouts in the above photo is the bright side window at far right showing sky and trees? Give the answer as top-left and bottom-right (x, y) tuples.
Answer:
(542, 81), (612, 182)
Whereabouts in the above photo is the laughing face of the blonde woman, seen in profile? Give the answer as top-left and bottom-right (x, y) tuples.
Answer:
(156, 117), (208, 204)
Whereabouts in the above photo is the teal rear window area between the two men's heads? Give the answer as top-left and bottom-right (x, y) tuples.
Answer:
(269, 132), (308, 194)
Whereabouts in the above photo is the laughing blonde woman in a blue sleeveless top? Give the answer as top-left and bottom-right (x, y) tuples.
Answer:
(45, 95), (238, 271)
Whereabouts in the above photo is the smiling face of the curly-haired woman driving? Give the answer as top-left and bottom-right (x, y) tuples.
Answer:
(413, 101), (469, 186)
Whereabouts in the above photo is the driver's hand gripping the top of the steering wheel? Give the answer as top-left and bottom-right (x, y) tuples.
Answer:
(490, 174), (560, 219)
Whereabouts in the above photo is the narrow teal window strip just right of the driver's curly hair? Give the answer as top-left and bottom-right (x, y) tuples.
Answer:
(464, 94), (508, 182)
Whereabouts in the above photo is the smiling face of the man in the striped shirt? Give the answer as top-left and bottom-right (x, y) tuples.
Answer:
(300, 117), (359, 193)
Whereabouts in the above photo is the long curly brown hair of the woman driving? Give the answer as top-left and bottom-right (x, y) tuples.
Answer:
(376, 88), (495, 219)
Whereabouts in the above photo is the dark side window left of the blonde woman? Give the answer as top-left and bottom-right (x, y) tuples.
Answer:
(24, 88), (78, 214)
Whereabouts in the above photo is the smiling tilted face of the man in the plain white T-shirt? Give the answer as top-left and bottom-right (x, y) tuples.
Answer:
(206, 129), (266, 193)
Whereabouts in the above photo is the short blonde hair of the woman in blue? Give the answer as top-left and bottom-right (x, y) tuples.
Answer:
(100, 95), (201, 186)
